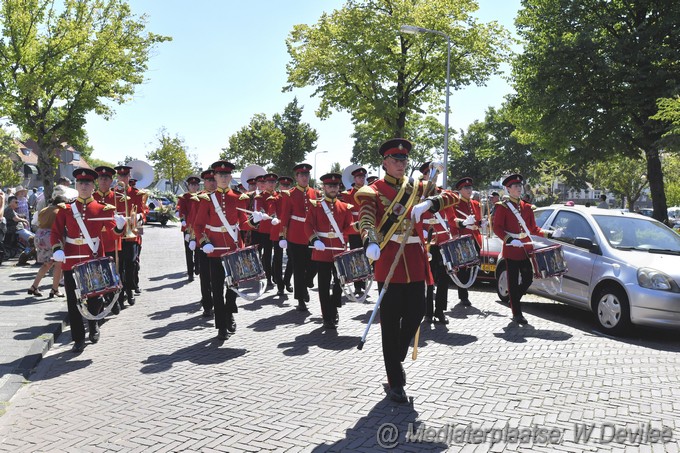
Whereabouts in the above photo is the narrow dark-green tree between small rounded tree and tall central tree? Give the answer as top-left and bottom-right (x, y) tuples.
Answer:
(272, 98), (319, 175)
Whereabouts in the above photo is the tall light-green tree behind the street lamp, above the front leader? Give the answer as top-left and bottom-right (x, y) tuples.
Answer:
(284, 0), (508, 141)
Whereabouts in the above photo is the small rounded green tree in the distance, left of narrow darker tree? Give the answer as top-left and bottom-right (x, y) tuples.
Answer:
(220, 113), (284, 170)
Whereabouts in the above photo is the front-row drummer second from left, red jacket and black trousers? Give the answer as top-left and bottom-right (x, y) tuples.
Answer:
(193, 160), (263, 340)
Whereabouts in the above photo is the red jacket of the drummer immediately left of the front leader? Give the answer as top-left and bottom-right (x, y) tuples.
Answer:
(305, 197), (358, 263)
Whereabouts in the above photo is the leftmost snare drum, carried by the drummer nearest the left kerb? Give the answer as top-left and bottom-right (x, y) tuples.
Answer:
(73, 256), (123, 299)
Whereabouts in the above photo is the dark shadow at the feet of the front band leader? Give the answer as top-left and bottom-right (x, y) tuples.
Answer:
(312, 398), (448, 453)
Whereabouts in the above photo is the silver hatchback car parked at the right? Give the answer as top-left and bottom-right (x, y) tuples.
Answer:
(496, 205), (680, 334)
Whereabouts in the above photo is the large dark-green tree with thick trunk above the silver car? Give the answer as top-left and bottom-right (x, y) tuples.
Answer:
(513, 0), (680, 220)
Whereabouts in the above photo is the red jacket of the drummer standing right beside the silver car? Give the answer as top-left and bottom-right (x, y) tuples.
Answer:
(493, 199), (547, 260)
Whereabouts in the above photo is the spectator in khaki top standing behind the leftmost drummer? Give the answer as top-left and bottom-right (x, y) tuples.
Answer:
(28, 195), (66, 299)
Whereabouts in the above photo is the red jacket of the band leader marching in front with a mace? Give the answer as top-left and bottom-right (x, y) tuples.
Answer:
(354, 175), (458, 283)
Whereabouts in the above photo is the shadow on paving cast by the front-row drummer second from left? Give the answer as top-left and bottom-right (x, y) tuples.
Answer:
(140, 338), (247, 374)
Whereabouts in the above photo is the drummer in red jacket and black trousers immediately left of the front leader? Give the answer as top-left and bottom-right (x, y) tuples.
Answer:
(305, 173), (357, 330)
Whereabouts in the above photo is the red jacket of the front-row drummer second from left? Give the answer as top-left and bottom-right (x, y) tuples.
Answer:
(193, 188), (257, 258)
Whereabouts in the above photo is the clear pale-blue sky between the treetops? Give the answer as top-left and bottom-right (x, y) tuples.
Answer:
(86, 0), (520, 174)
